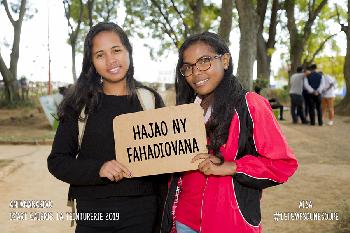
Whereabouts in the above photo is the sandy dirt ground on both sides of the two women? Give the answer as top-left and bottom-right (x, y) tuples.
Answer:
(0, 114), (350, 233)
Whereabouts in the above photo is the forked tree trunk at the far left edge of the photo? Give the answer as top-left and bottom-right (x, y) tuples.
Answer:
(0, 0), (26, 103)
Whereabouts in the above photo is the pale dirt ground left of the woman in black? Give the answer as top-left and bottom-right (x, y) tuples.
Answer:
(0, 145), (74, 233)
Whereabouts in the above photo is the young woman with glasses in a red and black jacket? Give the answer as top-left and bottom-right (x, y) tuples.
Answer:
(161, 32), (298, 233)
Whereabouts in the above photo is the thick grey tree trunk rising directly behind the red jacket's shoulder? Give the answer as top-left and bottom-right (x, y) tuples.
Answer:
(236, 0), (258, 90)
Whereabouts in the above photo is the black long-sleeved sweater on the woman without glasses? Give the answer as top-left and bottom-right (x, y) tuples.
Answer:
(47, 94), (162, 200)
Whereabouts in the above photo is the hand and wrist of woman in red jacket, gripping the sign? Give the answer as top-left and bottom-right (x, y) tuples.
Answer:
(191, 153), (236, 176)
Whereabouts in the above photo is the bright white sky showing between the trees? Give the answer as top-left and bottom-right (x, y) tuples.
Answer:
(0, 0), (346, 86)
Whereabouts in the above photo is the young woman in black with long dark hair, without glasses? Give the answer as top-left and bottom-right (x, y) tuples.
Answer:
(47, 23), (164, 233)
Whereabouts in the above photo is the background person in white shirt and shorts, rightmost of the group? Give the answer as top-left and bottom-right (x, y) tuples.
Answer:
(321, 75), (337, 125)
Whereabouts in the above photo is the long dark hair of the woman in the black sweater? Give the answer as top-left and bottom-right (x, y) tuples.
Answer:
(58, 22), (154, 119)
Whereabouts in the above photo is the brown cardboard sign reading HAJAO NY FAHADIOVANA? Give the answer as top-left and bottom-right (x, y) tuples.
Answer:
(113, 104), (208, 177)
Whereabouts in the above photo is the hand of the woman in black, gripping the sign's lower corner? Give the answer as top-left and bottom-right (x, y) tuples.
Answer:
(99, 160), (132, 181)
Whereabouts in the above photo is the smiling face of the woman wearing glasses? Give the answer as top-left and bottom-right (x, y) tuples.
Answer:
(183, 42), (230, 96)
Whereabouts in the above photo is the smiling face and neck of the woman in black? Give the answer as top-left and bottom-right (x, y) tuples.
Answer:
(92, 31), (130, 95)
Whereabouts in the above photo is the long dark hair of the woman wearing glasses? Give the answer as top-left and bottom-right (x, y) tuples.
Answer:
(175, 32), (245, 161)
